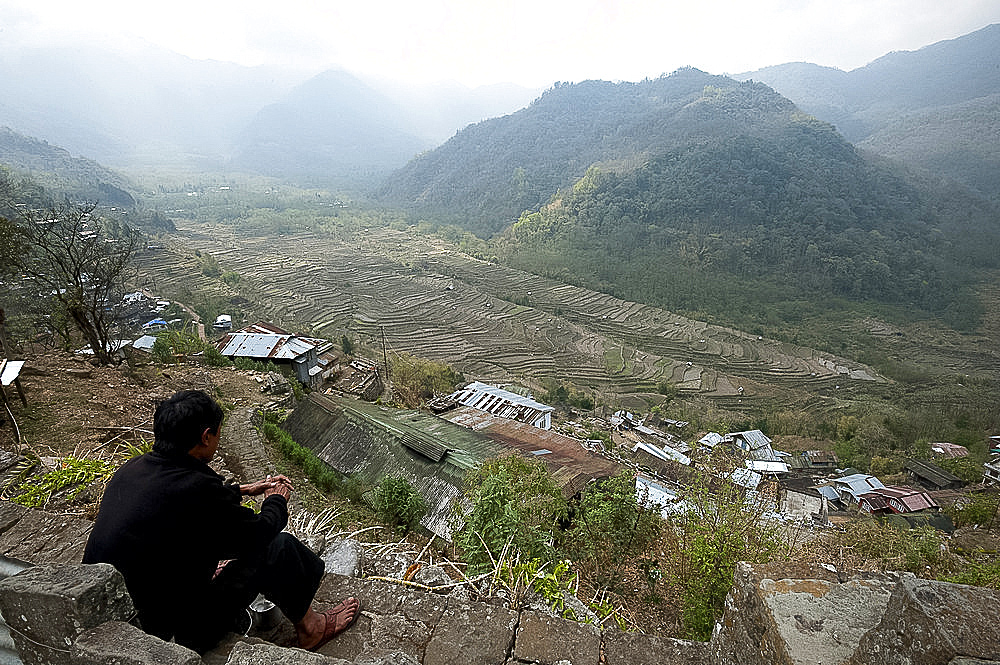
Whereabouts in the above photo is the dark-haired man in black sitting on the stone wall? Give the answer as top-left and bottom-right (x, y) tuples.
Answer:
(83, 390), (361, 653)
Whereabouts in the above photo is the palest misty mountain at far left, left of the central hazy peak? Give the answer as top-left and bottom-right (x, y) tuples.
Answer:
(0, 45), (301, 167)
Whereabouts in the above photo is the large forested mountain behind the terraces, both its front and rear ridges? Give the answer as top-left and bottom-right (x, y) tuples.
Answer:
(382, 69), (1000, 326)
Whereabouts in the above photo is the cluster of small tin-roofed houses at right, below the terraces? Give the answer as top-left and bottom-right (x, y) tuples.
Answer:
(611, 412), (1000, 527)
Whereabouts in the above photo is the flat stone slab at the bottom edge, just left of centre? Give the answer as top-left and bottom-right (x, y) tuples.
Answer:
(423, 603), (518, 665)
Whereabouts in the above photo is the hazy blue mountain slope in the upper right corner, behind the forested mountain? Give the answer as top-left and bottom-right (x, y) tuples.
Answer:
(737, 24), (1000, 197)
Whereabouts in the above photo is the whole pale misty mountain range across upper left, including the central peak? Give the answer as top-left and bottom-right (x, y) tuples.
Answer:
(0, 41), (536, 178)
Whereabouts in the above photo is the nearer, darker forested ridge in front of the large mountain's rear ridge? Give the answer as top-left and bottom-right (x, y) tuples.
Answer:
(497, 123), (1000, 328)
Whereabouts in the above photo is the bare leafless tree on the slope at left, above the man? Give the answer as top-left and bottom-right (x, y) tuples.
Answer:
(17, 203), (142, 365)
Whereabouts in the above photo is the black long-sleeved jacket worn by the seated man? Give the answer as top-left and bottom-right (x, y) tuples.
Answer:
(83, 451), (288, 639)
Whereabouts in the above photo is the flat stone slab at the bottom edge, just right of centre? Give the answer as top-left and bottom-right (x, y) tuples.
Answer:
(514, 610), (601, 665)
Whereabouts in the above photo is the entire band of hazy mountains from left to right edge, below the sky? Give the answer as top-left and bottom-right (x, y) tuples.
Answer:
(0, 26), (1000, 334)
